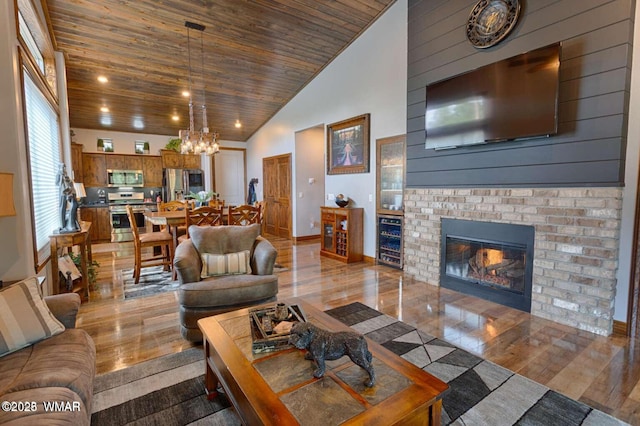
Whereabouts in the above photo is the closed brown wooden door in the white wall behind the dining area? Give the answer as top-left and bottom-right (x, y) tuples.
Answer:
(262, 154), (292, 239)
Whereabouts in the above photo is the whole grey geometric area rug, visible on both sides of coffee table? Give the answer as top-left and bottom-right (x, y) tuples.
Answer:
(91, 303), (626, 426)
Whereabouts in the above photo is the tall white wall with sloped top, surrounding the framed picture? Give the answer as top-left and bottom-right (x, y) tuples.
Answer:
(247, 0), (407, 257)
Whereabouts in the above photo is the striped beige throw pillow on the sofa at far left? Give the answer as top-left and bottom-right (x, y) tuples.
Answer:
(0, 277), (64, 356)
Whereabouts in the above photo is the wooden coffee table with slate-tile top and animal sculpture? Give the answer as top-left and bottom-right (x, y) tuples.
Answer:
(198, 298), (448, 426)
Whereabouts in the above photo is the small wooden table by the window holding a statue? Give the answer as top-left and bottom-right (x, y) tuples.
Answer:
(49, 221), (93, 301)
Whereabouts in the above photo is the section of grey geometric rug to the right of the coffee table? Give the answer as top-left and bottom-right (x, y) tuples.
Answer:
(326, 303), (626, 426)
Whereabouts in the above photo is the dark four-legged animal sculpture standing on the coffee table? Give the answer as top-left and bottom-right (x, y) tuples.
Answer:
(289, 322), (376, 387)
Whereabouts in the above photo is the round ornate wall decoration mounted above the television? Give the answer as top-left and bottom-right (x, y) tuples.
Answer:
(467, 0), (520, 49)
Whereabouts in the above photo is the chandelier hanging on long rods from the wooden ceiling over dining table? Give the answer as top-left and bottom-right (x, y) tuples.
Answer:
(180, 21), (220, 155)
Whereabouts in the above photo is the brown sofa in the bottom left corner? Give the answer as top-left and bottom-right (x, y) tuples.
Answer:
(0, 278), (96, 425)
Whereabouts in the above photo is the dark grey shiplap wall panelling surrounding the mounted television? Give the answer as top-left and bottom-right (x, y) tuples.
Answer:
(407, 0), (635, 188)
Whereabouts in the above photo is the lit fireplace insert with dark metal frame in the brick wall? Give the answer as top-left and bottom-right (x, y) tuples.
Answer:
(440, 219), (535, 312)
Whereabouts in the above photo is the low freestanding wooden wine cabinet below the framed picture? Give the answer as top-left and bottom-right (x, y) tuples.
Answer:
(320, 207), (364, 263)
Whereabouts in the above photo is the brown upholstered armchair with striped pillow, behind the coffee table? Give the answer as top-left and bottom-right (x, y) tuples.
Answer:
(174, 224), (278, 343)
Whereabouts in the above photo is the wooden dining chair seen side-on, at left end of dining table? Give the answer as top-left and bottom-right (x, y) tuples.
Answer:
(127, 206), (173, 284)
